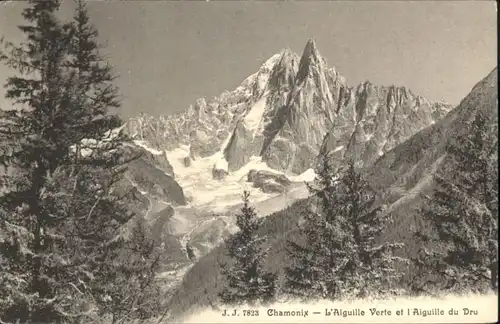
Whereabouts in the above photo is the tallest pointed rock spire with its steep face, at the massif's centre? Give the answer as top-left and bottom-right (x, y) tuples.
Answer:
(261, 41), (342, 174)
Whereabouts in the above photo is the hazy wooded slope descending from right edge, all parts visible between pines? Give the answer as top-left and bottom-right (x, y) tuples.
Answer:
(164, 69), (498, 318)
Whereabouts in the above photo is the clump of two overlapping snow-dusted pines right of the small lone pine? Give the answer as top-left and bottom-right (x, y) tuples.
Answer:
(286, 159), (404, 299)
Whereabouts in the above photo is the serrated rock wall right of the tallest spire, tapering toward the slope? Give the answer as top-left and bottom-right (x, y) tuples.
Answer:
(320, 82), (450, 167)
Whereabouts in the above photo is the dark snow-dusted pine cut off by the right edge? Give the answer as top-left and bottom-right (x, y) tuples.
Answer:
(414, 112), (498, 292)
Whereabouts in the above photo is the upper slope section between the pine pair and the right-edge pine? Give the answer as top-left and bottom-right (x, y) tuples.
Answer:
(367, 68), (498, 254)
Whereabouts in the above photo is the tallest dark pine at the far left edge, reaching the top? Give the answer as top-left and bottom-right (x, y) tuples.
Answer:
(0, 1), (77, 322)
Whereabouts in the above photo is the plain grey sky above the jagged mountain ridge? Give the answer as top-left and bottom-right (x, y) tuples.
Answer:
(0, 0), (497, 116)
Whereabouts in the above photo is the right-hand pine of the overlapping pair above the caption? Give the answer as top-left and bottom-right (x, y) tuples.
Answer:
(333, 162), (407, 298)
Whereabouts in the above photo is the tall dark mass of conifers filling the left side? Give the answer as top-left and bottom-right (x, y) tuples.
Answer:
(0, 0), (158, 323)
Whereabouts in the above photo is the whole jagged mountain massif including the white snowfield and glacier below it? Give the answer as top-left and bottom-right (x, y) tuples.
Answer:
(122, 40), (458, 270)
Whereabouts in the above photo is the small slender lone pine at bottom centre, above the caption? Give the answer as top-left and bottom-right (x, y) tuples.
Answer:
(219, 191), (276, 304)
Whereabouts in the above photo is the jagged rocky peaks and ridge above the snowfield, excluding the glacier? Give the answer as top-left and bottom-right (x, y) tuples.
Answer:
(128, 40), (451, 182)
